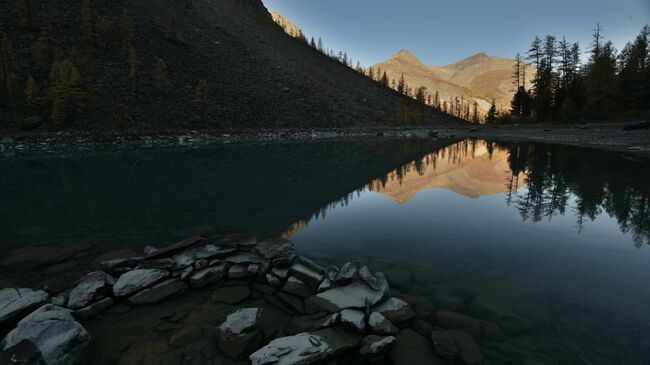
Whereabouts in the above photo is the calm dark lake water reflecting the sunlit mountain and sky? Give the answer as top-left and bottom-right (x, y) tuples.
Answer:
(0, 140), (650, 364)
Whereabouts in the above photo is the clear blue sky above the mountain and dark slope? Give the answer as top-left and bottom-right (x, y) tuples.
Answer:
(263, 0), (650, 65)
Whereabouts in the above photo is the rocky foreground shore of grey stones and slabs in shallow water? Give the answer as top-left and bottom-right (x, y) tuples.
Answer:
(0, 234), (531, 365)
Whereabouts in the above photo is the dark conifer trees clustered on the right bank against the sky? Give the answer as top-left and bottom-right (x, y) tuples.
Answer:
(502, 24), (650, 122)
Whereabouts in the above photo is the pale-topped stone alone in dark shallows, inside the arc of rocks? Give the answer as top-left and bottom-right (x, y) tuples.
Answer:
(217, 308), (262, 360)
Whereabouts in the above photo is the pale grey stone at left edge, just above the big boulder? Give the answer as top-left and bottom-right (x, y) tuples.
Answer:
(0, 288), (49, 328)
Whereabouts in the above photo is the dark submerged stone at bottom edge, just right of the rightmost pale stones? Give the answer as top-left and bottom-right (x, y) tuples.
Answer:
(388, 329), (453, 365)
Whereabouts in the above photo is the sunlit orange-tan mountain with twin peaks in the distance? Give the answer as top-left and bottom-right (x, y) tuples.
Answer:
(372, 50), (533, 112)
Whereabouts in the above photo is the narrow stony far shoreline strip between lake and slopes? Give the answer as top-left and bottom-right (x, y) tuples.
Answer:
(0, 123), (650, 158)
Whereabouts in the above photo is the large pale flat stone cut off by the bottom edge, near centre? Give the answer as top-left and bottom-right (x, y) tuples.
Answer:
(249, 328), (360, 365)
